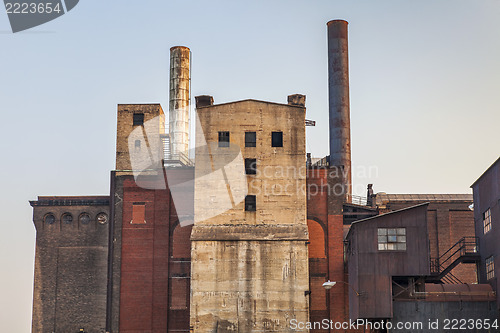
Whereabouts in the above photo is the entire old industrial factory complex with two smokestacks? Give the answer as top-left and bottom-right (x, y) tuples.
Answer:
(30, 20), (500, 333)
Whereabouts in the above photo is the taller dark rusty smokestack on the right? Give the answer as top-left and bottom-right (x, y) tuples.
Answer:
(326, 20), (352, 195)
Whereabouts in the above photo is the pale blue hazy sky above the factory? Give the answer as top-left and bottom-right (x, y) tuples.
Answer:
(0, 0), (500, 333)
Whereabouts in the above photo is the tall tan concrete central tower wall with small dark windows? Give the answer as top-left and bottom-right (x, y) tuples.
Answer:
(191, 100), (309, 332)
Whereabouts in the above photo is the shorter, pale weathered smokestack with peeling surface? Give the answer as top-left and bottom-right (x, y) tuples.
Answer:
(168, 46), (191, 155)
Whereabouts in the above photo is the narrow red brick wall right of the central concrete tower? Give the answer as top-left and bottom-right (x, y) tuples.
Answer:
(307, 168), (362, 333)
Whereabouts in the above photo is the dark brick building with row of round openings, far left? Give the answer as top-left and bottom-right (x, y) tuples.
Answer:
(31, 197), (109, 333)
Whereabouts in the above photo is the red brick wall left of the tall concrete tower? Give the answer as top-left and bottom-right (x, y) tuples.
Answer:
(116, 169), (193, 333)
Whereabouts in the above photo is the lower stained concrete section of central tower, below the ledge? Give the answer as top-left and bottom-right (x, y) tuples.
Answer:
(191, 241), (309, 332)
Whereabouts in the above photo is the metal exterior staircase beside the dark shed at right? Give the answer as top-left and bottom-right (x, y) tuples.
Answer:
(427, 237), (481, 284)
